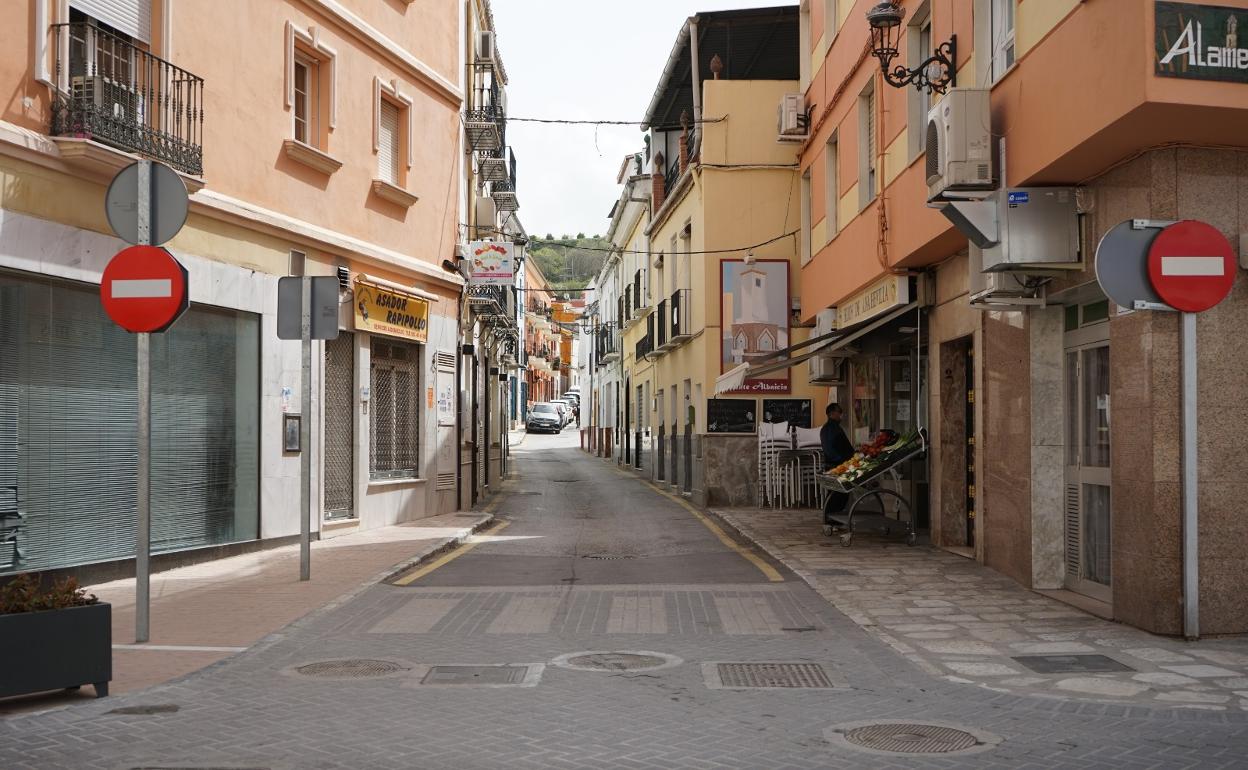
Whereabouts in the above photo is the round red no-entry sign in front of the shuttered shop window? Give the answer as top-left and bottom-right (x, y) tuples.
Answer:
(100, 246), (191, 332)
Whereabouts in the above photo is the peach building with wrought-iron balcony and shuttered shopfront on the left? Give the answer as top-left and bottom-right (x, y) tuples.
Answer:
(0, 0), (523, 577)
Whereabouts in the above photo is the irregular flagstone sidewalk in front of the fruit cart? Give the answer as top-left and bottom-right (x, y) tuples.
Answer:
(715, 509), (1248, 708)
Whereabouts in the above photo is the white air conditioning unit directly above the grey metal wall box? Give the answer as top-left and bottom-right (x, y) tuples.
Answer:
(925, 89), (993, 201)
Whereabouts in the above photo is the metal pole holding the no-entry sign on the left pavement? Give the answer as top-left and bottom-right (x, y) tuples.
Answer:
(135, 160), (152, 643)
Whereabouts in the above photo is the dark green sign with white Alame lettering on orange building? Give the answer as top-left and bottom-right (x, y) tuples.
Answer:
(1154, 2), (1248, 82)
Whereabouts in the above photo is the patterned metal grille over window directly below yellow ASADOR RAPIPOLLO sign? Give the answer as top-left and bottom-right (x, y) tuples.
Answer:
(368, 337), (421, 478)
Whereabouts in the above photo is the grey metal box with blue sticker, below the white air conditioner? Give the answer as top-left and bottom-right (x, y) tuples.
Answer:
(983, 187), (1083, 272)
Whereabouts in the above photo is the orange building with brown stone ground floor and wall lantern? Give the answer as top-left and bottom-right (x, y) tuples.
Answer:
(795, 0), (1248, 634)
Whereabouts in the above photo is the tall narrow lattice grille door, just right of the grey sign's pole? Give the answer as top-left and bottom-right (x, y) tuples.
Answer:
(324, 332), (356, 518)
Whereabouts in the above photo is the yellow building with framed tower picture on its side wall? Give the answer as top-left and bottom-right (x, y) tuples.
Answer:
(617, 9), (827, 505)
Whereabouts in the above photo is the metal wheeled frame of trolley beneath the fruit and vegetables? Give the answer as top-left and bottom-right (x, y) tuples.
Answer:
(815, 428), (927, 548)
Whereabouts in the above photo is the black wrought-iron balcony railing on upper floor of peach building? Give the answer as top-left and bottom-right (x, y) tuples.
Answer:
(51, 21), (203, 176)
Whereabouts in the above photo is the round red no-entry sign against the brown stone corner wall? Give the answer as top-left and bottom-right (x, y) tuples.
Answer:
(1148, 220), (1237, 313)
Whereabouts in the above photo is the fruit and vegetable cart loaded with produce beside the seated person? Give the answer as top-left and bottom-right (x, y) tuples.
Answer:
(815, 429), (927, 548)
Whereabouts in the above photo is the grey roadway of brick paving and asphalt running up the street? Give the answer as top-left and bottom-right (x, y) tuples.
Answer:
(0, 434), (1248, 770)
